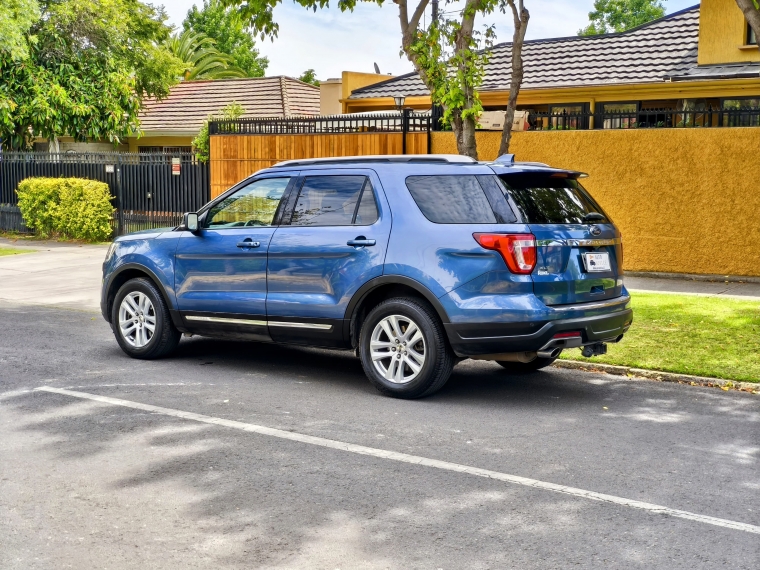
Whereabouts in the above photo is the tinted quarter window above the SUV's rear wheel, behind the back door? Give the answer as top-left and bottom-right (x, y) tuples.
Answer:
(406, 176), (496, 224)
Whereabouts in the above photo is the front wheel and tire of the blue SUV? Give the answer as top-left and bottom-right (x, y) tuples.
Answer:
(111, 278), (182, 360)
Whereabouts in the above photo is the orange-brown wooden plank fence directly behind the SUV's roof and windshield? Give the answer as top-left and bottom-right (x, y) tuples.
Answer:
(209, 132), (429, 198)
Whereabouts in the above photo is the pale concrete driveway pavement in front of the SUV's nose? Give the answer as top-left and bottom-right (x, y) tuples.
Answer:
(0, 239), (108, 311)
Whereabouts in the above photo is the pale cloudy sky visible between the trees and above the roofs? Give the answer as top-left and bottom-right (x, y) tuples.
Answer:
(159, 0), (699, 80)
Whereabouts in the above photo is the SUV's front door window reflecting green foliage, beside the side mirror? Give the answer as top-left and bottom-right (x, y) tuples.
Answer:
(205, 177), (290, 229)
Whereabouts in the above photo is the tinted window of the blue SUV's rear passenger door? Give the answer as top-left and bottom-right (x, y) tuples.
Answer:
(290, 175), (378, 226)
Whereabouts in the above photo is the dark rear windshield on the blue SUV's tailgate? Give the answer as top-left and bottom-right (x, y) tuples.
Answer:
(500, 173), (609, 224)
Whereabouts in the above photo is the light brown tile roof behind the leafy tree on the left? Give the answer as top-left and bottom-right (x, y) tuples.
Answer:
(140, 76), (319, 134)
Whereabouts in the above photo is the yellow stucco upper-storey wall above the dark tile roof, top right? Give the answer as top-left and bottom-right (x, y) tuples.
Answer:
(697, 0), (760, 65)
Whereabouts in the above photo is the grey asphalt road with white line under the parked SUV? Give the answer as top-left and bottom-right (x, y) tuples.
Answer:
(0, 303), (760, 570)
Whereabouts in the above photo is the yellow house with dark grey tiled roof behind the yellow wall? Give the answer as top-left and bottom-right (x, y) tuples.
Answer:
(342, 0), (760, 130)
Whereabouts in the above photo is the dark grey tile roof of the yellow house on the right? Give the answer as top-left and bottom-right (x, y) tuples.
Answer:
(350, 6), (760, 99)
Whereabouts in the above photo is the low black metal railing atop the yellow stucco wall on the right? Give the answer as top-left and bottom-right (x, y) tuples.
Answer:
(528, 108), (760, 131)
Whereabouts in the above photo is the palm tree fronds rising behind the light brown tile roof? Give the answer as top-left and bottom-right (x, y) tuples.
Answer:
(167, 30), (246, 81)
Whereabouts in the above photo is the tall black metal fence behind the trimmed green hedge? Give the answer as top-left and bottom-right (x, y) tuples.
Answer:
(0, 152), (211, 235)
